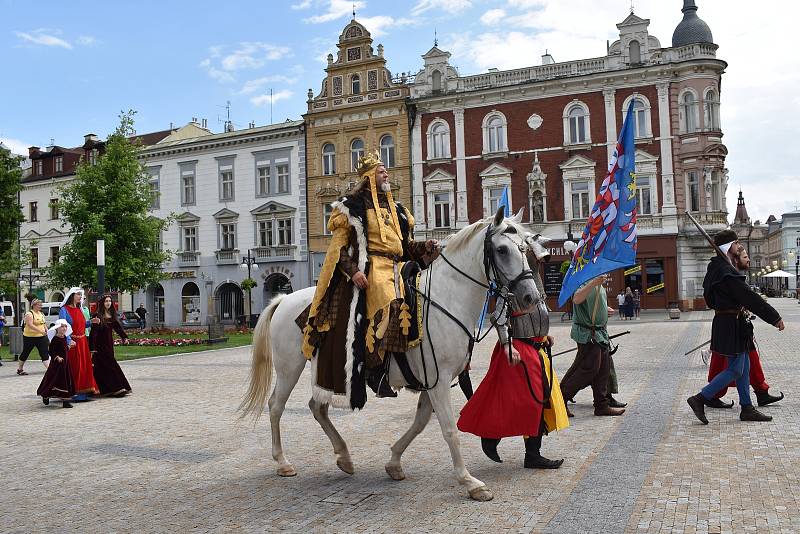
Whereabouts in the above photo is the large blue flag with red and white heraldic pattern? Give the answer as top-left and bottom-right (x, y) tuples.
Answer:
(558, 100), (637, 306)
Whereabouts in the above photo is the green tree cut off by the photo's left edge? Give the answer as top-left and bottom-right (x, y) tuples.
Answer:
(0, 148), (25, 297)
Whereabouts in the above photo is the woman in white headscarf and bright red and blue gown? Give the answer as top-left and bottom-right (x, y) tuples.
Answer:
(58, 287), (100, 402)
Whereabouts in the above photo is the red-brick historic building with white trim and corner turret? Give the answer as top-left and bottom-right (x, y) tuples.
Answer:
(411, 0), (727, 309)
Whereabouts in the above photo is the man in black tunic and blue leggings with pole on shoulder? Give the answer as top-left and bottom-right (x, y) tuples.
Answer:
(686, 228), (784, 425)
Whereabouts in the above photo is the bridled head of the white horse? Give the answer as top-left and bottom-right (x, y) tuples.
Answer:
(484, 208), (542, 313)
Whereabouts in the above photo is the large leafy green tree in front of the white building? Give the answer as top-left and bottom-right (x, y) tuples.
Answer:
(45, 111), (171, 291)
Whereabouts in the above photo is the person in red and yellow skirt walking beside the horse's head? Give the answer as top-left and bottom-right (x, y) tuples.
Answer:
(458, 238), (569, 469)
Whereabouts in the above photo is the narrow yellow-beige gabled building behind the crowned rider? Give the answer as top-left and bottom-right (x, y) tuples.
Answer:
(303, 19), (411, 280)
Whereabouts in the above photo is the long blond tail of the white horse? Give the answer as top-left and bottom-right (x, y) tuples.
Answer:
(237, 295), (285, 421)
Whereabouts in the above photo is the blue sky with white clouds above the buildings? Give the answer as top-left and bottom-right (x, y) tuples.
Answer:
(0, 0), (800, 221)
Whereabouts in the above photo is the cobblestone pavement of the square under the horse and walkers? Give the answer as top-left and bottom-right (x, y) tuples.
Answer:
(0, 299), (800, 534)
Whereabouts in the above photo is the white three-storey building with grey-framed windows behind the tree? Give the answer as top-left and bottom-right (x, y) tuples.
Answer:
(137, 121), (310, 326)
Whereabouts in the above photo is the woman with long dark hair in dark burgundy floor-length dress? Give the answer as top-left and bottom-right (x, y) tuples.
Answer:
(89, 295), (131, 397)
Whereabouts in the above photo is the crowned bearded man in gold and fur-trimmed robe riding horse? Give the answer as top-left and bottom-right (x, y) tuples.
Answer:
(297, 153), (438, 409)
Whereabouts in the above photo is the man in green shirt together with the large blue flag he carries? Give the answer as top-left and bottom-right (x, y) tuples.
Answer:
(558, 101), (637, 416)
